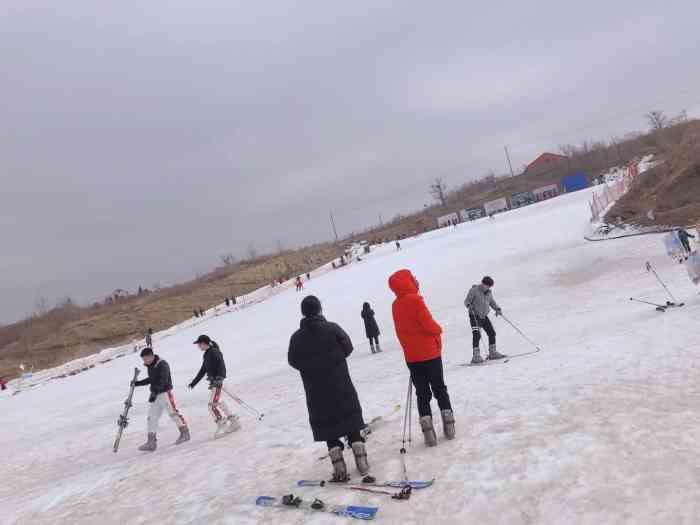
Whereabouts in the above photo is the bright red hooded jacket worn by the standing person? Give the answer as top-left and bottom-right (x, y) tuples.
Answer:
(389, 270), (442, 363)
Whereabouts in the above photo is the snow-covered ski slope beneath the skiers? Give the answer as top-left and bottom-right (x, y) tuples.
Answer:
(0, 191), (700, 525)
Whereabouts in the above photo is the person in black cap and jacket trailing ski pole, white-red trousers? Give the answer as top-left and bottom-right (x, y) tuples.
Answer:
(189, 335), (241, 437)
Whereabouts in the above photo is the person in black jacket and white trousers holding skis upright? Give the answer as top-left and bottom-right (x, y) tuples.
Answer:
(132, 348), (190, 452)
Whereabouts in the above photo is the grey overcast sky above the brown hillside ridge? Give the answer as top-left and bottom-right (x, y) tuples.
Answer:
(0, 0), (700, 322)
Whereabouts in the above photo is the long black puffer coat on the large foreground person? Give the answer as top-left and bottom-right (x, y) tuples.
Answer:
(288, 315), (365, 441)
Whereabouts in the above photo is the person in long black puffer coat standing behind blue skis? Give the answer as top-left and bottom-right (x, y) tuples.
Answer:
(287, 295), (369, 481)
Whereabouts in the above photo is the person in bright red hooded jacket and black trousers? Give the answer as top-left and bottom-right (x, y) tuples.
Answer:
(389, 270), (455, 447)
